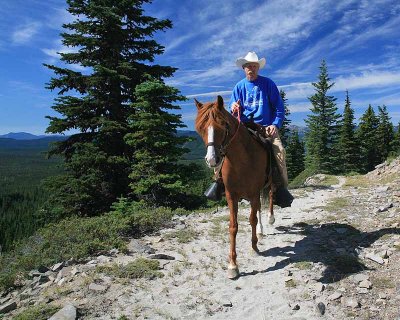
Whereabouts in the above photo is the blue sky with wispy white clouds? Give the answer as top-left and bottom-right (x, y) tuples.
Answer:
(0, 0), (400, 134)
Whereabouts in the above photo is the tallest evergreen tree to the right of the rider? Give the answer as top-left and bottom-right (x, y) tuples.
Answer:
(305, 60), (340, 173)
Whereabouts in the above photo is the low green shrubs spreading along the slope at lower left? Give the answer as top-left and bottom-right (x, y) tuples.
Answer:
(0, 199), (182, 290)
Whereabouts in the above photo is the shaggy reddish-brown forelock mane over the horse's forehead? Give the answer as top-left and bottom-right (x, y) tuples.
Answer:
(196, 102), (230, 134)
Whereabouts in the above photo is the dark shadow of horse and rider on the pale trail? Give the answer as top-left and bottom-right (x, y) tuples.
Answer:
(241, 223), (400, 283)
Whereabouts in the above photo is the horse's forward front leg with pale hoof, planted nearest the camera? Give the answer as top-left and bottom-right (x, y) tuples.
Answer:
(226, 192), (239, 279)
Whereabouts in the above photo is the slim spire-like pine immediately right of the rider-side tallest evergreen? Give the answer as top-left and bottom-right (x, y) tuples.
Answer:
(338, 91), (360, 173)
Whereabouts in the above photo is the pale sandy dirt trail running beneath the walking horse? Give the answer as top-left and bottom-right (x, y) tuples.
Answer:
(98, 180), (344, 319)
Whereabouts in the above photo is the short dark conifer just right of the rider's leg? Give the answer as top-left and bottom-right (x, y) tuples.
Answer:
(286, 130), (304, 181)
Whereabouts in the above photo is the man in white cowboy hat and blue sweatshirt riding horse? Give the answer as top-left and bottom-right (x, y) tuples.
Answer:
(208, 52), (293, 208)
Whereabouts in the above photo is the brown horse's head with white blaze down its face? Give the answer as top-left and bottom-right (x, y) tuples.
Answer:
(195, 96), (231, 168)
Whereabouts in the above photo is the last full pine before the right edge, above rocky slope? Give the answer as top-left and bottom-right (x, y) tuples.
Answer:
(376, 105), (394, 163)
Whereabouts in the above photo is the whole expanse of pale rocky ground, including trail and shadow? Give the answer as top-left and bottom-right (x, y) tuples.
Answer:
(0, 159), (400, 320)
